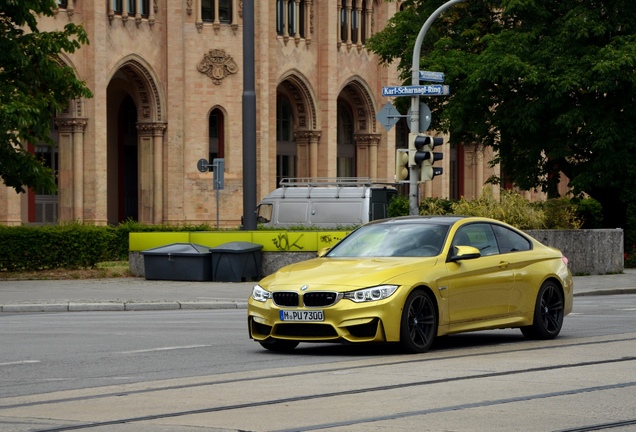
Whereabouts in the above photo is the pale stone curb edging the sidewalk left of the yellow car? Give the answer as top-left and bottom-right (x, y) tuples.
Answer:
(0, 301), (247, 313)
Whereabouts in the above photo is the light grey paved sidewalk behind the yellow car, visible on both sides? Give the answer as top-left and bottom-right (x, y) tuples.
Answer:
(0, 269), (636, 312)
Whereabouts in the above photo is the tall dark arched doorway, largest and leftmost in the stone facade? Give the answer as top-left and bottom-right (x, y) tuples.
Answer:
(106, 60), (166, 225)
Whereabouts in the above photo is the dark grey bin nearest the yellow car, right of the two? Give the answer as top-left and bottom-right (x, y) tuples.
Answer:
(210, 242), (263, 282)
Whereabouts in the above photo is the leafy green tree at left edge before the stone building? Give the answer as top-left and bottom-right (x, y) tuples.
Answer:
(0, 0), (92, 193)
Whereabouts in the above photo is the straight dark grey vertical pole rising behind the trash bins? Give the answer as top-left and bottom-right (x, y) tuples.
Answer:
(243, 0), (256, 230)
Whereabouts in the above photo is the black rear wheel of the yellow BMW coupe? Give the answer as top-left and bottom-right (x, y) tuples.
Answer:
(521, 281), (564, 340)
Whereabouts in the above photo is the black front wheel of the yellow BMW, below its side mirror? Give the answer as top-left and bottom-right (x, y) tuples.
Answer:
(400, 290), (437, 353)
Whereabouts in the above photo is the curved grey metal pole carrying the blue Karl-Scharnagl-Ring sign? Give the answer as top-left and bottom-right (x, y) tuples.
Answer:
(409, 0), (465, 215)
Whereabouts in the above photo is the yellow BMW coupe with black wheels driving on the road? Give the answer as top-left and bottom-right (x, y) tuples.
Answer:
(247, 216), (573, 353)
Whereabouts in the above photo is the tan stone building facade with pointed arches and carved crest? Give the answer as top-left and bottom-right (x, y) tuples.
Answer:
(0, 0), (520, 227)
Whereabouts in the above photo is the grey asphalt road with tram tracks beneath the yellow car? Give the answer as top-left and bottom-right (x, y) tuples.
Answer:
(0, 295), (636, 432)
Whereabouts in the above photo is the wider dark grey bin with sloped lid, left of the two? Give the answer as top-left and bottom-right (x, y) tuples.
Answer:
(141, 243), (212, 281)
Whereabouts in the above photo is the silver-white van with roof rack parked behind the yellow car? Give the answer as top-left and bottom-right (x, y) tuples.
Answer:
(257, 178), (397, 229)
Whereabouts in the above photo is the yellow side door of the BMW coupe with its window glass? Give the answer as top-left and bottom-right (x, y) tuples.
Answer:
(445, 223), (514, 326)
